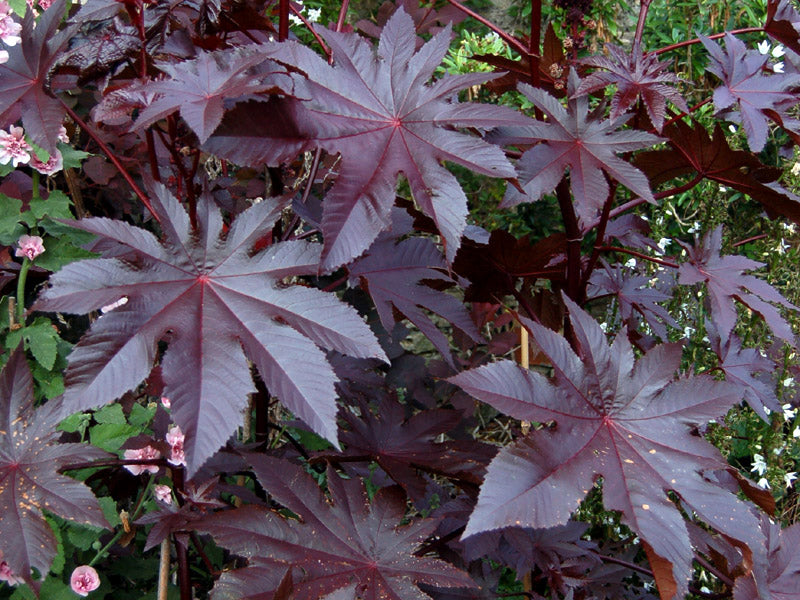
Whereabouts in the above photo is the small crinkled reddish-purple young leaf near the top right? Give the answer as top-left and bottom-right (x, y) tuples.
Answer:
(575, 44), (689, 132)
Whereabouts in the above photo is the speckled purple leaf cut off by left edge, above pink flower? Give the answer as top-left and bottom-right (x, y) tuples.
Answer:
(0, 350), (108, 589)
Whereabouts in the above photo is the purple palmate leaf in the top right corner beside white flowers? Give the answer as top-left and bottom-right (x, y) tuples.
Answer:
(701, 33), (800, 152)
